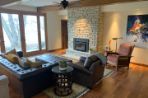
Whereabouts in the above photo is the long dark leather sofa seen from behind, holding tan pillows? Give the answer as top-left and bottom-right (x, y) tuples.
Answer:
(0, 56), (55, 98)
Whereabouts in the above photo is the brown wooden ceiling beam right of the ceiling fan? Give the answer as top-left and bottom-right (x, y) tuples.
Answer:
(80, 0), (147, 6)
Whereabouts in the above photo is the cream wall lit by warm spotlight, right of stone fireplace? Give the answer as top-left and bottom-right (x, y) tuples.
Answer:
(102, 2), (148, 65)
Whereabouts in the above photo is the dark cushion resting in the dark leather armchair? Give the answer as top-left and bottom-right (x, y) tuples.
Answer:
(84, 55), (99, 69)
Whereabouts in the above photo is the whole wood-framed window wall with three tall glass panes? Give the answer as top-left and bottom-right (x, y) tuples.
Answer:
(0, 10), (46, 54)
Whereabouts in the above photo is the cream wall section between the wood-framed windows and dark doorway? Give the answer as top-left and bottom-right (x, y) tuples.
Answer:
(47, 11), (67, 50)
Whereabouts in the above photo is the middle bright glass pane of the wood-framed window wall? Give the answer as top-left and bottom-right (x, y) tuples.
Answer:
(23, 15), (39, 52)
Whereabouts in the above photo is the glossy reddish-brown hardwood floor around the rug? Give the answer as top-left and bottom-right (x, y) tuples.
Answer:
(10, 51), (148, 98)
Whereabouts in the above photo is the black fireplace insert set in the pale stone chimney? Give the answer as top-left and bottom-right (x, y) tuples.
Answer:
(73, 38), (89, 52)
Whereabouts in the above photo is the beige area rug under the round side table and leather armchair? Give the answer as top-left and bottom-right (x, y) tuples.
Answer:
(44, 69), (113, 98)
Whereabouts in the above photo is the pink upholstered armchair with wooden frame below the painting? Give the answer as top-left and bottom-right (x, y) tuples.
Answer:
(107, 43), (134, 70)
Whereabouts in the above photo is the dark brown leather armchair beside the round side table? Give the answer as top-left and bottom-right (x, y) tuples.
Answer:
(69, 54), (104, 88)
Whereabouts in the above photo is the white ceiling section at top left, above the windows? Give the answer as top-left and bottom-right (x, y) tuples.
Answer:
(0, 0), (79, 7)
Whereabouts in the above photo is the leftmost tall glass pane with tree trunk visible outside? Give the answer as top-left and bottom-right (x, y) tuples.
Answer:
(1, 13), (22, 52)
